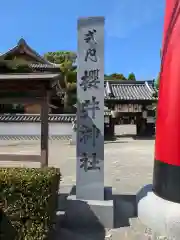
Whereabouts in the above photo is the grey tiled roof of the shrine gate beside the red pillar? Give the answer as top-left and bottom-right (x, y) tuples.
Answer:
(105, 80), (155, 100)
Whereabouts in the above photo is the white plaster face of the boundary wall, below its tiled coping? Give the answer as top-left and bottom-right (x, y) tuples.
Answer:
(0, 122), (72, 136)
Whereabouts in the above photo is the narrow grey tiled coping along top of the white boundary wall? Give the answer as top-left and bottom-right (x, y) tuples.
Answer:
(0, 110), (111, 123)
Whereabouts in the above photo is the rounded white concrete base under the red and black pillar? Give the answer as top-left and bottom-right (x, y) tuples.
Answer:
(137, 186), (180, 240)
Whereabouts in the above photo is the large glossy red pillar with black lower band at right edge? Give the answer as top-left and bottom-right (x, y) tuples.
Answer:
(153, 0), (180, 203)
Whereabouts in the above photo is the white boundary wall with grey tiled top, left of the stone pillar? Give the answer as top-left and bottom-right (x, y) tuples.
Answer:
(0, 112), (110, 139)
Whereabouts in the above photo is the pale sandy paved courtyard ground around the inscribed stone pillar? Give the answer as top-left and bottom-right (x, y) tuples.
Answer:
(0, 126), (165, 240)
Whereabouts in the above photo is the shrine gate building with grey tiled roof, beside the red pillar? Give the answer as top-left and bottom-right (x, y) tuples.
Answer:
(104, 80), (157, 135)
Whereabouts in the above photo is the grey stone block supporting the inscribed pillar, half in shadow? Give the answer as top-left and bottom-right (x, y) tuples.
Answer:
(58, 186), (114, 228)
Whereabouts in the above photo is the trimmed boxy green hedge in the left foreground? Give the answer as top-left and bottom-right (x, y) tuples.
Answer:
(0, 168), (60, 240)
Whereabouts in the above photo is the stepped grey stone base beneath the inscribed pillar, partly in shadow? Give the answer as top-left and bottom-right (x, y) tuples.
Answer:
(57, 185), (114, 229)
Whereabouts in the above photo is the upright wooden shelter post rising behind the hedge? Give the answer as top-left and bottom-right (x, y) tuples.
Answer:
(41, 91), (49, 167)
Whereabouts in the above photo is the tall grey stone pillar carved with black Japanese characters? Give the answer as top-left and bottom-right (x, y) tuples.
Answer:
(76, 17), (104, 200)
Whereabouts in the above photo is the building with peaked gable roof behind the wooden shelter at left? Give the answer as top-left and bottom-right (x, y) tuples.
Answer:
(0, 39), (63, 114)
